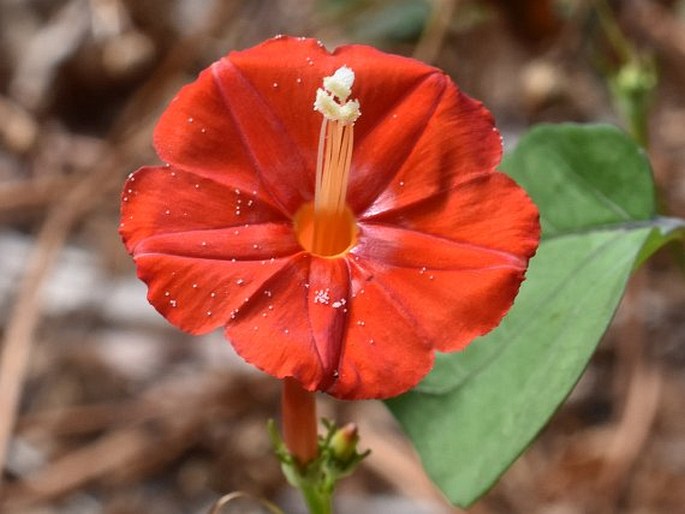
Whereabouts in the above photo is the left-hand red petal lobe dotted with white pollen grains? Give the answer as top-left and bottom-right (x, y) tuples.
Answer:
(120, 167), (302, 334)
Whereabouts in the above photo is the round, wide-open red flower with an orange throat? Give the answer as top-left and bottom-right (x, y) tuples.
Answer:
(120, 37), (539, 398)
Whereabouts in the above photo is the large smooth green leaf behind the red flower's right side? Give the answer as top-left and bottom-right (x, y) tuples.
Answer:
(387, 125), (685, 507)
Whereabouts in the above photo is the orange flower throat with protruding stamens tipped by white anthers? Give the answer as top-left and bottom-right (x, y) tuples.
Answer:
(295, 66), (361, 257)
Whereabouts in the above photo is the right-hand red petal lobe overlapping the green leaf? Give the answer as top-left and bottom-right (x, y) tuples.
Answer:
(351, 173), (540, 351)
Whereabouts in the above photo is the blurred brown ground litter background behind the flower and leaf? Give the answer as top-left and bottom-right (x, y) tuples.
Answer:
(0, 0), (685, 514)
